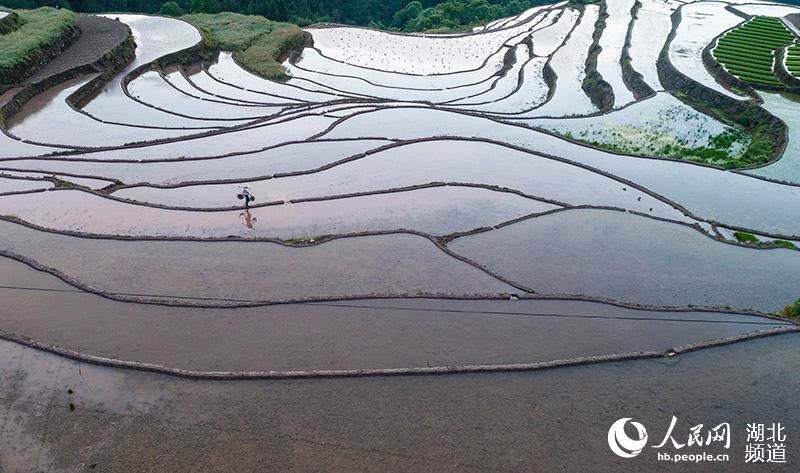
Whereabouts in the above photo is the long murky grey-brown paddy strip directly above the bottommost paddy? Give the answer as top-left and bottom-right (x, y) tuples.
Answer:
(0, 254), (780, 371)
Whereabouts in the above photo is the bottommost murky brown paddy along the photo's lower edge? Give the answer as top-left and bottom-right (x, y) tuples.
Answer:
(0, 326), (800, 473)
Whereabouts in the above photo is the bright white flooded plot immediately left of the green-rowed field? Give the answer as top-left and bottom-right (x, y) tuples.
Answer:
(669, 2), (745, 99)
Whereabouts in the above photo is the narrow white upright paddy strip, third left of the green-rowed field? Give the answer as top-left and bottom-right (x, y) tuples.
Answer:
(597, 0), (634, 107)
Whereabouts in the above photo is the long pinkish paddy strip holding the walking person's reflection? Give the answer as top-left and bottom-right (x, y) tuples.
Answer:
(0, 186), (558, 239)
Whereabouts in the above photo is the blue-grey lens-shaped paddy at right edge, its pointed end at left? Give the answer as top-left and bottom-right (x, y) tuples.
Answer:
(448, 210), (800, 311)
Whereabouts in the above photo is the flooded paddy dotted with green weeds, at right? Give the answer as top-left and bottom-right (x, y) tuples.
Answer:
(525, 92), (749, 164)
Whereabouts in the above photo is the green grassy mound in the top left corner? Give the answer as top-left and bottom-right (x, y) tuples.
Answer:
(0, 7), (76, 83)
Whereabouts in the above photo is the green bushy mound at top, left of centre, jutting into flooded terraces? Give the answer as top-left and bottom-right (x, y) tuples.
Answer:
(181, 13), (305, 80)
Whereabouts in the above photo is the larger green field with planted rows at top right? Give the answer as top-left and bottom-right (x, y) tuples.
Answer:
(713, 16), (800, 86)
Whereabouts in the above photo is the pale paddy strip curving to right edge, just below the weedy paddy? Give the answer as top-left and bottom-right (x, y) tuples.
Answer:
(318, 106), (800, 236)
